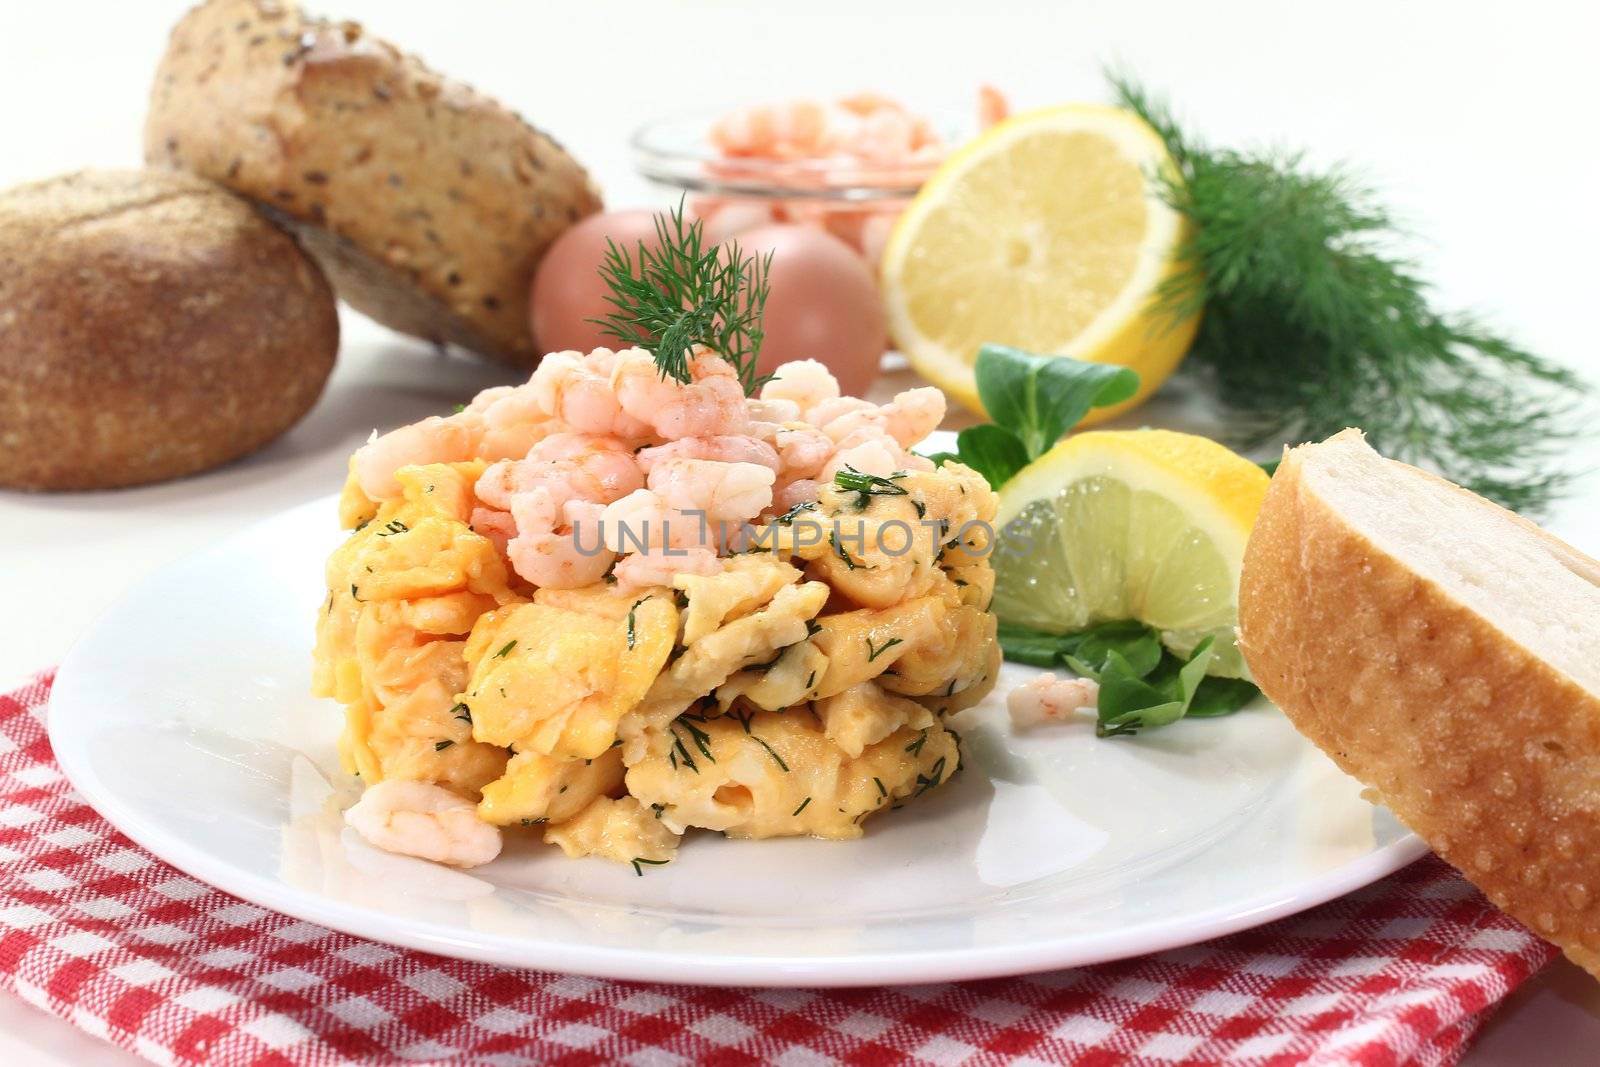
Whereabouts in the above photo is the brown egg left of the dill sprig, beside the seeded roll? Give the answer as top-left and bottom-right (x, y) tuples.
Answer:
(528, 210), (656, 352)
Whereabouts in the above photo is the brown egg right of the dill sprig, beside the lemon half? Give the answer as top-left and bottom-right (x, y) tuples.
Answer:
(738, 224), (888, 397)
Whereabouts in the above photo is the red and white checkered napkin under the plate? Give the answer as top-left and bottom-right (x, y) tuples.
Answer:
(0, 677), (1555, 1067)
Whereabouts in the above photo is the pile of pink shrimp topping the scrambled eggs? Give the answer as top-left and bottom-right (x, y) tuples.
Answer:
(350, 349), (944, 589)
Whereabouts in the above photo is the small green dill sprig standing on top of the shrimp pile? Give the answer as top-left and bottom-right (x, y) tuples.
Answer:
(592, 200), (773, 397)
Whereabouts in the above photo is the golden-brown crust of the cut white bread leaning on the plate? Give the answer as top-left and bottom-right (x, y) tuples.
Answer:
(1238, 430), (1600, 976)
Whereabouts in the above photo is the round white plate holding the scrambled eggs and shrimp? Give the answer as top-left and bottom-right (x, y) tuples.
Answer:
(50, 499), (1424, 985)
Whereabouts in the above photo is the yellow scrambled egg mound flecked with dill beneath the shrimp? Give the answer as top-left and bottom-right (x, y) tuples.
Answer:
(314, 462), (1000, 870)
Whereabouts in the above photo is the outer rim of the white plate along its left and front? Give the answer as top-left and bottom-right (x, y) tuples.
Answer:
(45, 498), (1429, 987)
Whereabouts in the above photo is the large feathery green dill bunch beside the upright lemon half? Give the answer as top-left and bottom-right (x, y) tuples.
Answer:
(1109, 74), (1582, 512)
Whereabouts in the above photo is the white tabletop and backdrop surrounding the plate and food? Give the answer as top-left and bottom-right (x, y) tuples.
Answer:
(0, 0), (1600, 1065)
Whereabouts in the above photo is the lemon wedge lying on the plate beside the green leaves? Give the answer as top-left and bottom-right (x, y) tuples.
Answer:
(992, 430), (1269, 678)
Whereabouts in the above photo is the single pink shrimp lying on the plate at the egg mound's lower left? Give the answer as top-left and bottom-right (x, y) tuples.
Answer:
(344, 779), (501, 867)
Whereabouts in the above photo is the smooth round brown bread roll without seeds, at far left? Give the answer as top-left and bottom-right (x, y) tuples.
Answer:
(0, 171), (339, 490)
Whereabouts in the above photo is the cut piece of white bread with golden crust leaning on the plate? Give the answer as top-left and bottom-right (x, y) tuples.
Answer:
(1238, 430), (1600, 976)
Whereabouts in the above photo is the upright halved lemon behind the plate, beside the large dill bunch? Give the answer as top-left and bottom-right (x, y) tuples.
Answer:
(882, 104), (1198, 422)
